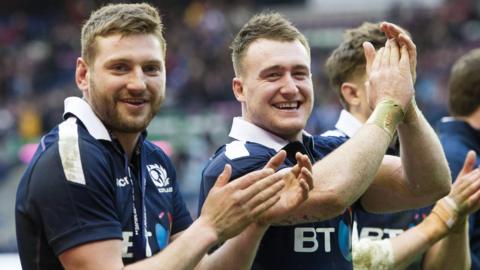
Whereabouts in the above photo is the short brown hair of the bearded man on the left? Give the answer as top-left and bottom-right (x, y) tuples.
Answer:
(81, 3), (166, 63)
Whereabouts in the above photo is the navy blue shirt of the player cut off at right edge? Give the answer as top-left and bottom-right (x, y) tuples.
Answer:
(436, 117), (480, 270)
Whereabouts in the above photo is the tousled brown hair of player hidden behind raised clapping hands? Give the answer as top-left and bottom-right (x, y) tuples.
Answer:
(325, 22), (387, 108)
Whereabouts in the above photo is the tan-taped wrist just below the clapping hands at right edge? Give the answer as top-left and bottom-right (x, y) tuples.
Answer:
(417, 196), (458, 243)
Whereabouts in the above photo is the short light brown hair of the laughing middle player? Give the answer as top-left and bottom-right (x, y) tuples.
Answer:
(230, 11), (310, 75)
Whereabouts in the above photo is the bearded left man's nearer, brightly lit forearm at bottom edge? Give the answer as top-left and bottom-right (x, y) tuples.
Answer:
(125, 218), (218, 270)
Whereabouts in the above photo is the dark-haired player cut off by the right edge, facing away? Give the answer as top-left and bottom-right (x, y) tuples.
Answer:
(431, 49), (480, 270)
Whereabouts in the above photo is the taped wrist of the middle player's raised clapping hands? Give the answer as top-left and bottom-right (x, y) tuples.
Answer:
(367, 100), (405, 140)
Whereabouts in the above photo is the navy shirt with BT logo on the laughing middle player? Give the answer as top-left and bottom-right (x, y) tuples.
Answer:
(199, 118), (353, 270)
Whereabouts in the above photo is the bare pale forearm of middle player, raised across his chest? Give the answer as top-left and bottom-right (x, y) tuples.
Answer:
(304, 124), (390, 220)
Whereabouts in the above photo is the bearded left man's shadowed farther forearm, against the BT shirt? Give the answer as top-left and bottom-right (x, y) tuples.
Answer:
(196, 223), (268, 270)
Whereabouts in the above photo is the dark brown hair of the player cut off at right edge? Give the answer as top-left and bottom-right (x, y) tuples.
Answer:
(448, 49), (480, 116)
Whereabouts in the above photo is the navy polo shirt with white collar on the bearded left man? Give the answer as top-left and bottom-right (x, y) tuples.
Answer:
(15, 97), (192, 270)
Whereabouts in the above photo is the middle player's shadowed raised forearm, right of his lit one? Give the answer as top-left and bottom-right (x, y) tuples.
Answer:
(398, 101), (451, 201)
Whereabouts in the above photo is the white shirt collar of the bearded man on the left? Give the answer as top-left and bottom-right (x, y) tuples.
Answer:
(63, 97), (112, 141)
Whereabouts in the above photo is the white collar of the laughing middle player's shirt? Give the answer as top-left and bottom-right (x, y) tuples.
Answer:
(228, 117), (311, 151)
